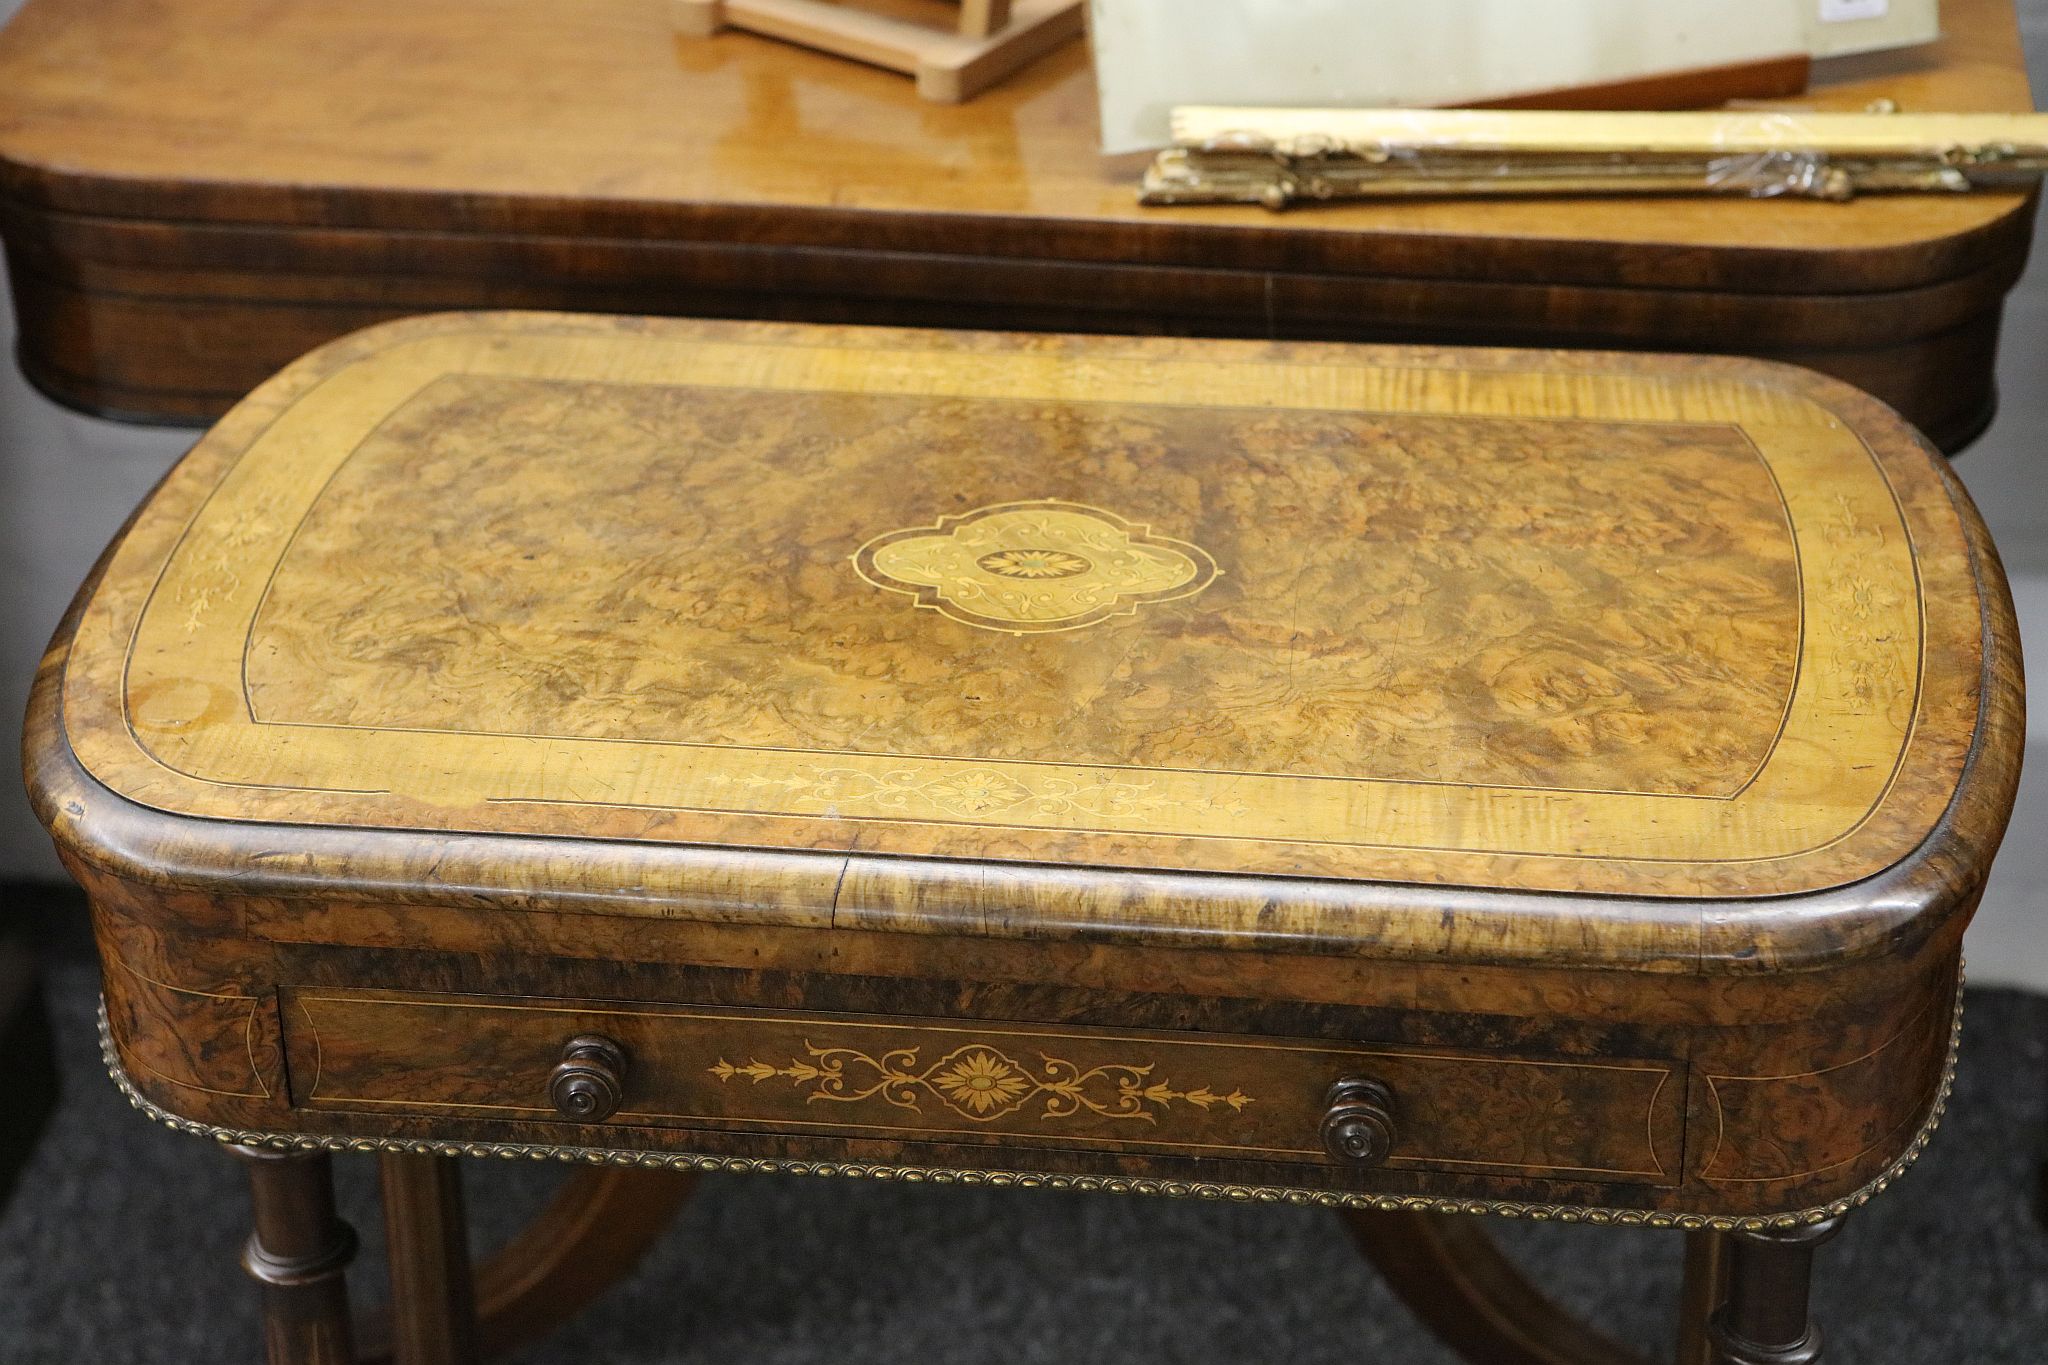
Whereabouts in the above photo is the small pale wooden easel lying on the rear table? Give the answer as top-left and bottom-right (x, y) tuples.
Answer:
(670, 0), (1085, 104)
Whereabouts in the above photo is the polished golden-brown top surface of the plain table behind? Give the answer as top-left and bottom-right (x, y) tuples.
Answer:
(0, 0), (2032, 266)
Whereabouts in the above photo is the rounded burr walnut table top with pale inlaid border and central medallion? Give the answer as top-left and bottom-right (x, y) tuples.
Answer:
(39, 315), (2011, 968)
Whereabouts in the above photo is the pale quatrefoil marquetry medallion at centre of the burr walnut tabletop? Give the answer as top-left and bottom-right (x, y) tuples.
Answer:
(854, 499), (1221, 634)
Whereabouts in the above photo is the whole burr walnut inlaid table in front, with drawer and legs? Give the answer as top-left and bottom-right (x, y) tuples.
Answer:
(29, 313), (2021, 1365)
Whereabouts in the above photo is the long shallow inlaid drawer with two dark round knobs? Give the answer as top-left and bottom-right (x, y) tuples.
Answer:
(285, 988), (1686, 1185)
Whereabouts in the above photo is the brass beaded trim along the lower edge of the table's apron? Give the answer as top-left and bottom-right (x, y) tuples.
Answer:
(100, 970), (1962, 1232)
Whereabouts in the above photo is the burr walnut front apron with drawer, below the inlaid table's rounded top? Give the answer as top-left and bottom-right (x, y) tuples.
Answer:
(80, 868), (1958, 1220)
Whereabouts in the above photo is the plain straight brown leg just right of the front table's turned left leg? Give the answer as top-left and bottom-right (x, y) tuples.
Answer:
(377, 1152), (481, 1365)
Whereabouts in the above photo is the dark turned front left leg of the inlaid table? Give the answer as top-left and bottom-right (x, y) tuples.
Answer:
(229, 1146), (356, 1365)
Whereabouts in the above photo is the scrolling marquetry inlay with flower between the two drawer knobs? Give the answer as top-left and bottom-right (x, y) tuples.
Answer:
(711, 1042), (1251, 1124)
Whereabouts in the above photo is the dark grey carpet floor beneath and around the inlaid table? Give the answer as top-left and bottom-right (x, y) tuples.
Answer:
(0, 964), (2048, 1365)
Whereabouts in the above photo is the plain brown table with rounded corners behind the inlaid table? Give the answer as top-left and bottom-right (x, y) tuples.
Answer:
(0, 0), (2032, 450)
